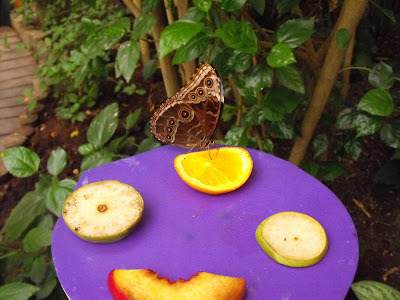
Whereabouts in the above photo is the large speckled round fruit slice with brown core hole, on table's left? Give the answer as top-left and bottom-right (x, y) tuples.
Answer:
(63, 180), (144, 243)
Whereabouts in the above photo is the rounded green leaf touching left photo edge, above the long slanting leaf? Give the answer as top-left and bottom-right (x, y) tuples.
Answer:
(1, 146), (40, 178)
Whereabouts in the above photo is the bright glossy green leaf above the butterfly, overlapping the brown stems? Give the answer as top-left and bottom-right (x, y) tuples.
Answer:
(159, 20), (204, 58)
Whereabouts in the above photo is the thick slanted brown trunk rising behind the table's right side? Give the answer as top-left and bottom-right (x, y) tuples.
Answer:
(289, 0), (368, 166)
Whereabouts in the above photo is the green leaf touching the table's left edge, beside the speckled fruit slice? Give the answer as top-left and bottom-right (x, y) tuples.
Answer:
(46, 179), (76, 217)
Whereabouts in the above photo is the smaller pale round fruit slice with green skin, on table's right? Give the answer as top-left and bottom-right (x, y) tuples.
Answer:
(256, 211), (328, 267)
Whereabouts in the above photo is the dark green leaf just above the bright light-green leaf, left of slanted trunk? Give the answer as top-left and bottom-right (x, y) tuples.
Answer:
(276, 17), (315, 48)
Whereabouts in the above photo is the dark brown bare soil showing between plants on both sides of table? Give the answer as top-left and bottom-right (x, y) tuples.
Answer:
(0, 64), (400, 299)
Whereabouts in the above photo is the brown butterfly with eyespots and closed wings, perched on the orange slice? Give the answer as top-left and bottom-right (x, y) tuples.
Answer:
(150, 63), (224, 148)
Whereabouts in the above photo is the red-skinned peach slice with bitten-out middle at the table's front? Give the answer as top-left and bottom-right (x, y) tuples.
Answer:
(108, 270), (246, 300)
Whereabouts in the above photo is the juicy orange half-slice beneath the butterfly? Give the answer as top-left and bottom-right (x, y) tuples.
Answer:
(174, 147), (253, 194)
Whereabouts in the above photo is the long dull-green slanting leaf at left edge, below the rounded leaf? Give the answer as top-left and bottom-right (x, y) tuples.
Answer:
(1, 192), (46, 240)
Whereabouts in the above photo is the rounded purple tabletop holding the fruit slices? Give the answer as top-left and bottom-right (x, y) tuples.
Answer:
(52, 146), (358, 300)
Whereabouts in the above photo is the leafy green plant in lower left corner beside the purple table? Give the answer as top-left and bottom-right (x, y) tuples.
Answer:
(0, 146), (76, 300)
